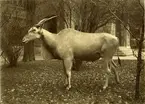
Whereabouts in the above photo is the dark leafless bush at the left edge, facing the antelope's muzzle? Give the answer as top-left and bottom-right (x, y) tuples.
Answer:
(1, 21), (22, 66)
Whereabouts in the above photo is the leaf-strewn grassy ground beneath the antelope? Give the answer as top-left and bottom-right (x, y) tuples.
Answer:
(2, 60), (145, 104)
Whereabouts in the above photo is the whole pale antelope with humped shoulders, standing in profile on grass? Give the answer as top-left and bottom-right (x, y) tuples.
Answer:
(23, 17), (119, 89)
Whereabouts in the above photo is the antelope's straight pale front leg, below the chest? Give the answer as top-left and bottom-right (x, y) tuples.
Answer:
(64, 59), (73, 90)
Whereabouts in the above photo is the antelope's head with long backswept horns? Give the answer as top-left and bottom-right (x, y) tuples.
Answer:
(22, 16), (57, 43)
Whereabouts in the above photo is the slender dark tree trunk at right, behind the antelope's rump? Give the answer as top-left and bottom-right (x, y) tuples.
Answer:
(135, 24), (144, 100)
